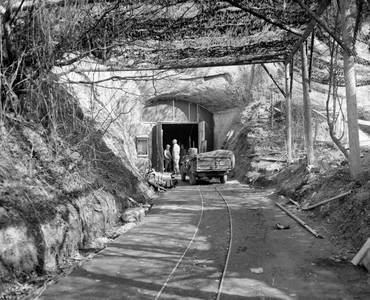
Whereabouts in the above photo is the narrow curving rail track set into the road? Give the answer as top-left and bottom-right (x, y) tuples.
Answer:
(155, 186), (233, 300)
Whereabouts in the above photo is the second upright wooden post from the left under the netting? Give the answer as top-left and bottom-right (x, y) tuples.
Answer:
(301, 43), (315, 165)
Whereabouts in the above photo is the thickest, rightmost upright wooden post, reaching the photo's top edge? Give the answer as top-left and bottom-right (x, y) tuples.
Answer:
(340, 0), (361, 179)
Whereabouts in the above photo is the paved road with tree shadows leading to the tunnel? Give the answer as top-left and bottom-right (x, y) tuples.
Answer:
(42, 182), (370, 300)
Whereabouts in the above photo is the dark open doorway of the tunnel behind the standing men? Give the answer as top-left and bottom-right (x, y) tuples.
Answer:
(162, 123), (198, 149)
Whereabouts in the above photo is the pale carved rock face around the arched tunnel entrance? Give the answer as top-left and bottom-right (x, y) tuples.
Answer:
(55, 61), (273, 172)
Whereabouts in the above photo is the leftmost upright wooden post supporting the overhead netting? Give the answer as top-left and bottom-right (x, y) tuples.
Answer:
(285, 63), (293, 164)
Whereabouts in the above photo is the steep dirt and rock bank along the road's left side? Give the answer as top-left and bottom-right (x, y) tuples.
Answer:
(0, 103), (151, 298)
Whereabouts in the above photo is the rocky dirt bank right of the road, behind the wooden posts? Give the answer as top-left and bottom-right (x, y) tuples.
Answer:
(227, 96), (370, 255)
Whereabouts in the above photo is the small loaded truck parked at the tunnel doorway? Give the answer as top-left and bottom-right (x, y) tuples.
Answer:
(180, 150), (235, 185)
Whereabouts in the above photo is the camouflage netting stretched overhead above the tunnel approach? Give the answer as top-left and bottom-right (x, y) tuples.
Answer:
(5, 0), (324, 68)
